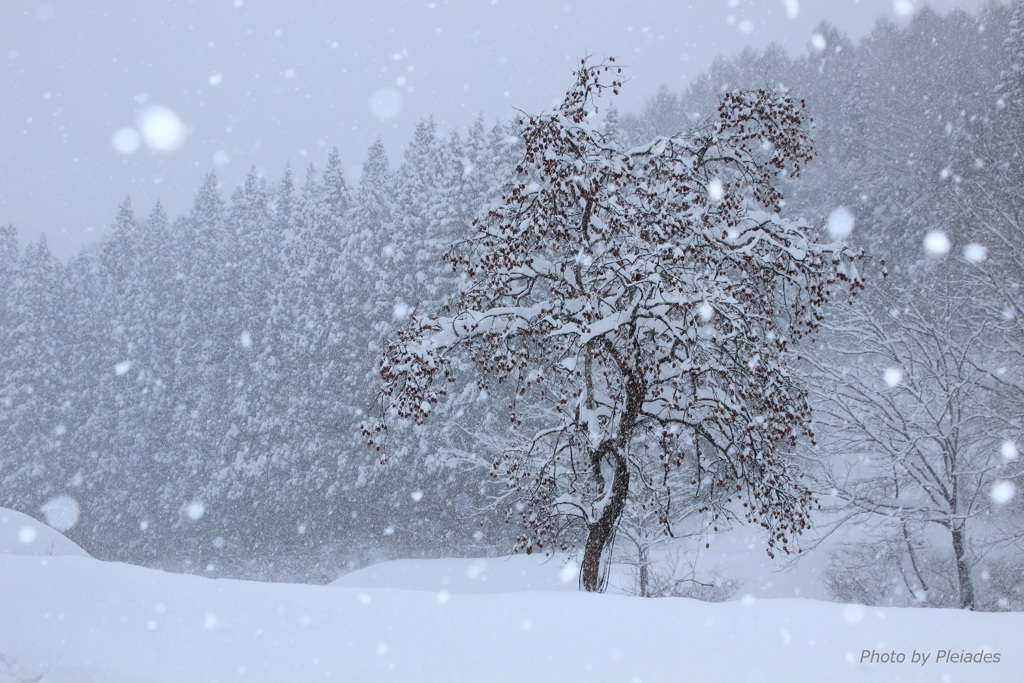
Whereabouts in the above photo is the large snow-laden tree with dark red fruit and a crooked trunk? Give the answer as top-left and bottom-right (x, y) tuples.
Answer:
(366, 60), (860, 591)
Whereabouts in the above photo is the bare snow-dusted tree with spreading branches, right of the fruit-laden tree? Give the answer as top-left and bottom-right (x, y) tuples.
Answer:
(814, 280), (1022, 609)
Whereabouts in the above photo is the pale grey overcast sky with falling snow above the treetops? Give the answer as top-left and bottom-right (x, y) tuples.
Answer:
(0, 0), (981, 258)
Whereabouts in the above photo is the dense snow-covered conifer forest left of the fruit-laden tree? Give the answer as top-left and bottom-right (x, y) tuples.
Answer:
(0, 120), (515, 578)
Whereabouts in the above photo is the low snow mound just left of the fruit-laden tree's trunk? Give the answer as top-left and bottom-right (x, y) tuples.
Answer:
(330, 555), (580, 595)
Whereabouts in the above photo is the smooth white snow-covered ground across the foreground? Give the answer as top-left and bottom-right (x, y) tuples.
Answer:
(0, 510), (1024, 683)
